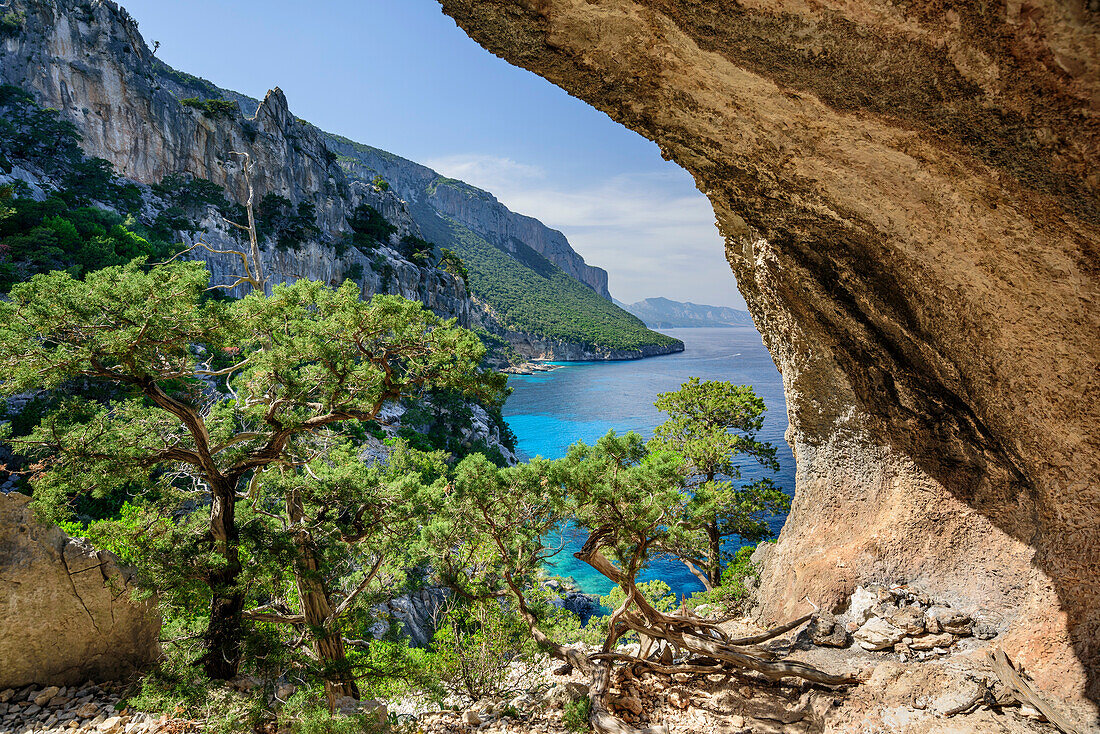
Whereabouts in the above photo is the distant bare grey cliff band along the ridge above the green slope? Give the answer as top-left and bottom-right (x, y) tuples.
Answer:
(327, 135), (612, 298)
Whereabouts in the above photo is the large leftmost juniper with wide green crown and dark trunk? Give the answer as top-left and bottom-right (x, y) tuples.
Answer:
(0, 262), (503, 679)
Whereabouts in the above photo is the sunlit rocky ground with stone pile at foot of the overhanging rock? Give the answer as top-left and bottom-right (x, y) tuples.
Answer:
(416, 585), (1100, 734)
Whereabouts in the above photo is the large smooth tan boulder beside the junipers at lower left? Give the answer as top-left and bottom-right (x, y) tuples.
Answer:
(0, 493), (161, 691)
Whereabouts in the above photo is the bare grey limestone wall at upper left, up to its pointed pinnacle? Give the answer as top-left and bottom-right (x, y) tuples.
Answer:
(0, 0), (348, 230)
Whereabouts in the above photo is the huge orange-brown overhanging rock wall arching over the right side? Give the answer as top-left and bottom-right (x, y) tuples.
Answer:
(441, 0), (1100, 700)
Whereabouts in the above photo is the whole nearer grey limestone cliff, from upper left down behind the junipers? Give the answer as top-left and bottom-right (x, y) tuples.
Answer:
(0, 0), (471, 325)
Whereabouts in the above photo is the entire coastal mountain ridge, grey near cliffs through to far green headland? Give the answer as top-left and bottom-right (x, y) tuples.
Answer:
(0, 0), (682, 359)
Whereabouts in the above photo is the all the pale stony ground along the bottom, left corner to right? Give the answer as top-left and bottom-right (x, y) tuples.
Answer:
(0, 585), (1100, 734)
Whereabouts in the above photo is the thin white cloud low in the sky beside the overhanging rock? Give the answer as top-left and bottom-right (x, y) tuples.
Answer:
(426, 155), (744, 308)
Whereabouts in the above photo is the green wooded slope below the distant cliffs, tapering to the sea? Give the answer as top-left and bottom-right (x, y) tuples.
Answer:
(413, 205), (679, 350)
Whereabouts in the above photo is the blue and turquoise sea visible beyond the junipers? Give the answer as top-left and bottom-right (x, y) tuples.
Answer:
(504, 327), (794, 594)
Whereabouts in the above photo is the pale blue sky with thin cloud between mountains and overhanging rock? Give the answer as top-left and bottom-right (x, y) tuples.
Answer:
(116, 0), (744, 308)
